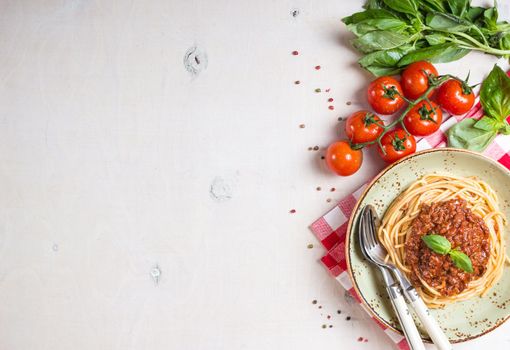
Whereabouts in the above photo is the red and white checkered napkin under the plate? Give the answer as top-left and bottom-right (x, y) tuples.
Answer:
(310, 71), (510, 350)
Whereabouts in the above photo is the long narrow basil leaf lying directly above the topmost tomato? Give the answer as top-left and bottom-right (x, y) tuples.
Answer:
(398, 43), (470, 67)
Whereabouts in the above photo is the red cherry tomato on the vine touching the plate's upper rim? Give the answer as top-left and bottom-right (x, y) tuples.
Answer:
(377, 129), (416, 163)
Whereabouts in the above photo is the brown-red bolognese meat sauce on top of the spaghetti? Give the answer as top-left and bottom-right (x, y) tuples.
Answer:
(405, 199), (490, 296)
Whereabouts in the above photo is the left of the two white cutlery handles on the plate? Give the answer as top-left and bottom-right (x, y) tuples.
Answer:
(386, 285), (425, 350)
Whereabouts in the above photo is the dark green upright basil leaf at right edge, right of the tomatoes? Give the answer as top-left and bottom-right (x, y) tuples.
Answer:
(480, 65), (510, 121)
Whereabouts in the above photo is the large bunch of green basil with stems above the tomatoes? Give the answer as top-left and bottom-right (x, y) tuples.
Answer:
(342, 0), (510, 76)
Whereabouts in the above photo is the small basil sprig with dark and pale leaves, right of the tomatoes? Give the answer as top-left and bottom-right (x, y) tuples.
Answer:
(447, 66), (510, 152)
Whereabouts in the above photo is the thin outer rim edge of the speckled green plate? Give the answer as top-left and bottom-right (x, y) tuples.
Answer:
(345, 147), (510, 343)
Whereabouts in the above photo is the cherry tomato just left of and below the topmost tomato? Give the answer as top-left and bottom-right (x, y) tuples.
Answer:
(368, 77), (404, 114)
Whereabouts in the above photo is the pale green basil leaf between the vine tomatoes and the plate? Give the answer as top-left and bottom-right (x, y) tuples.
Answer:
(446, 118), (497, 152)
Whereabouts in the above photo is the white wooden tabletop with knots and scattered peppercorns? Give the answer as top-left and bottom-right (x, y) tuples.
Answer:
(0, 0), (510, 350)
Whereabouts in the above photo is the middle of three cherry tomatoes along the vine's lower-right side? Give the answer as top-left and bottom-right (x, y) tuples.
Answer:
(404, 101), (443, 136)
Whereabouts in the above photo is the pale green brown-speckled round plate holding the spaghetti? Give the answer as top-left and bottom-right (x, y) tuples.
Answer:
(346, 148), (510, 343)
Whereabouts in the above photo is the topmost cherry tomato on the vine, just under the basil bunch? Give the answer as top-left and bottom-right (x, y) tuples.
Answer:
(401, 61), (438, 100)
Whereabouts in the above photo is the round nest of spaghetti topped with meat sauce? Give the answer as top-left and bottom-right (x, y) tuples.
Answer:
(378, 174), (508, 308)
